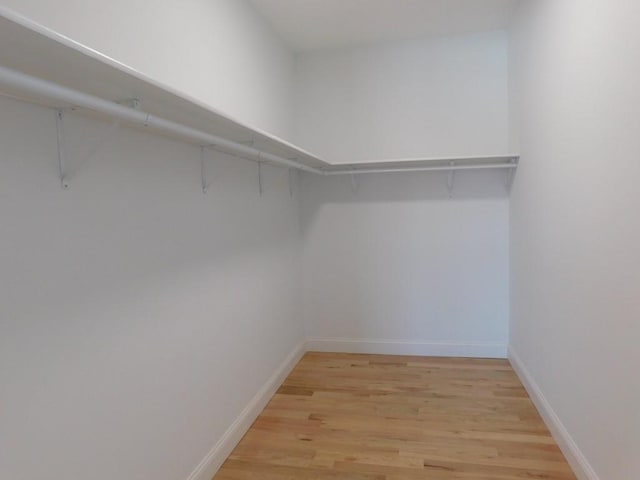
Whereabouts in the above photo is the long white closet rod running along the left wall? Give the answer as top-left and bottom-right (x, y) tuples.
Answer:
(0, 66), (323, 174)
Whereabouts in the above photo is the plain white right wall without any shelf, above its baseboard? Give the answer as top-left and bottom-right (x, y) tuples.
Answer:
(510, 0), (640, 480)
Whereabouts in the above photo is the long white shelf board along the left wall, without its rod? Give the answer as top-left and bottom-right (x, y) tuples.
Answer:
(0, 6), (329, 168)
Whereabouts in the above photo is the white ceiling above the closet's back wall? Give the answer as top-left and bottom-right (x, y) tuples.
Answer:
(250, 0), (519, 52)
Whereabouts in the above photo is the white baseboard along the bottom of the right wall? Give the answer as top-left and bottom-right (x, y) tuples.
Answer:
(509, 346), (600, 480)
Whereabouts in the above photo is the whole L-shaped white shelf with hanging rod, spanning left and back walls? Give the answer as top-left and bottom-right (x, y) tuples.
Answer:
(0, 6), (518, 175)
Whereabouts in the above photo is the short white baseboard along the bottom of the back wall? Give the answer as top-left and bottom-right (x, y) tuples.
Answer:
(307, 338), (507, 358)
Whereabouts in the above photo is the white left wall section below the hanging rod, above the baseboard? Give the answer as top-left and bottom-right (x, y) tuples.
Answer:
(0, 98), (303, 480)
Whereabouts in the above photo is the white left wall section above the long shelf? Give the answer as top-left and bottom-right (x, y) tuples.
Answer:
(0, 0), (293, 138)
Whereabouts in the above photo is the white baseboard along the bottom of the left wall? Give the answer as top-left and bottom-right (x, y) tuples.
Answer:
(187, 342), (306, 480)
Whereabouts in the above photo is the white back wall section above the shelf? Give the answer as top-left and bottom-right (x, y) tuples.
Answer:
(294, 32), (508, 163)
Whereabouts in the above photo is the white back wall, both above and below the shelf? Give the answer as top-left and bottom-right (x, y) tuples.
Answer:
(296, 32), (509, 356)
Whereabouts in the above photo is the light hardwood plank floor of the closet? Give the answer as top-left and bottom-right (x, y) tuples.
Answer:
(214, 352), (575, 480)
